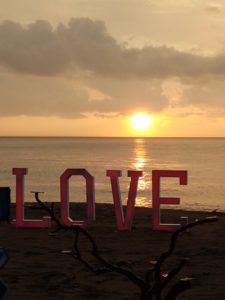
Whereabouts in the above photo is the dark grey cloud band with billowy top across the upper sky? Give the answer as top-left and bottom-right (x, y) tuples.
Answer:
(0, 18), (225, 79)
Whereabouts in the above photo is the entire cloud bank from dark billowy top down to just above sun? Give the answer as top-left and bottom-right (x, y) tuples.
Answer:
(0, 18), (225, 118)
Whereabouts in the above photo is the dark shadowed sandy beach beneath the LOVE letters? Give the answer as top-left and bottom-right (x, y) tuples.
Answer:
(0, 203), (225, 300)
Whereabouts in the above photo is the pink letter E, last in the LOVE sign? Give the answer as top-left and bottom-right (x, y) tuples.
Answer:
(152, 170), (187, 231)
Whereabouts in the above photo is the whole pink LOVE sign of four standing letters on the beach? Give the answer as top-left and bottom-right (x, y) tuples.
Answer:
(6, 168), (187, 231)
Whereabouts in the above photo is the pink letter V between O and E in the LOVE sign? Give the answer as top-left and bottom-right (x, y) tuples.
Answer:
(106, 170), (142, 231)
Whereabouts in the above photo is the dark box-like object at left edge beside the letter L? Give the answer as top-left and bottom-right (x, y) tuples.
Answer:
(0, 187), (11, 222)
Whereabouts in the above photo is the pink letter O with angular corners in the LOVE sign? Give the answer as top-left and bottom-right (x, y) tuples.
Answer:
(60, 169), (95, 226)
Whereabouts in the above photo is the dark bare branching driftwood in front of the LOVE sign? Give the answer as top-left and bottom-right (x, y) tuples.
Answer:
(34, 192), (218, 300)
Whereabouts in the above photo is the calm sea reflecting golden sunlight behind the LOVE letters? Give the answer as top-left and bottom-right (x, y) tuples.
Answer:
(0, 137), (225, 211)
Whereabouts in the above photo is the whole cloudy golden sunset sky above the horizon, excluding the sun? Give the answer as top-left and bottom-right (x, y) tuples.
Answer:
(0, 0), (225, 137)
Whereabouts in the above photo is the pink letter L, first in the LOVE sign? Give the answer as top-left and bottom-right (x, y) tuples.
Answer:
(13, 168), (49, 228)
